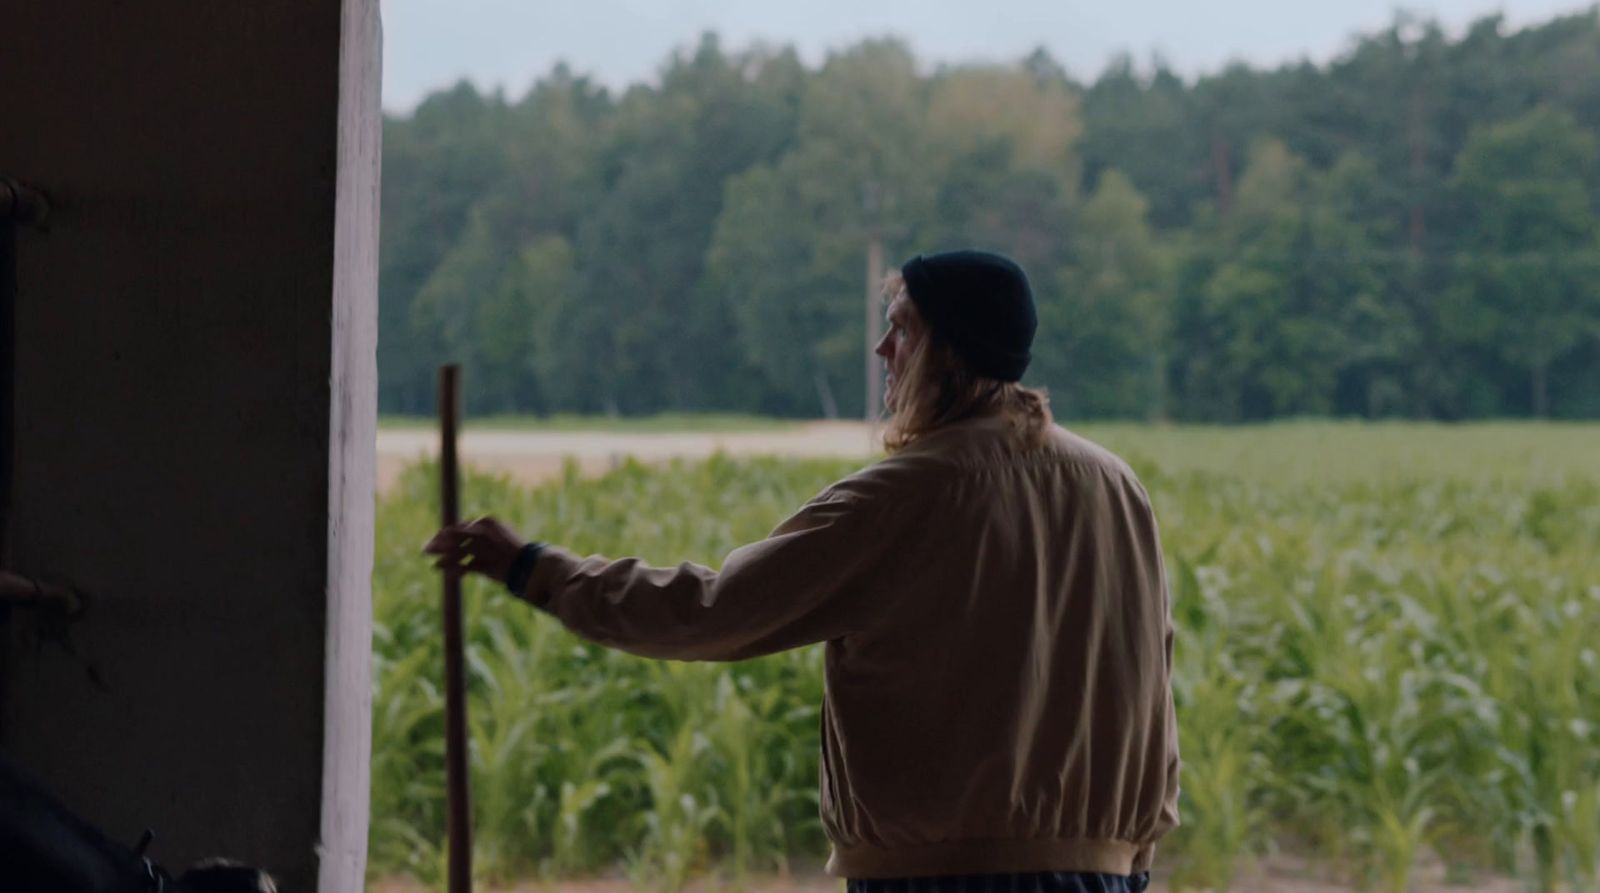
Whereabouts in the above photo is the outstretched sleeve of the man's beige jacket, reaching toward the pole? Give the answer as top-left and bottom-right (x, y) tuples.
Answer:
(523, 485), (906, 661)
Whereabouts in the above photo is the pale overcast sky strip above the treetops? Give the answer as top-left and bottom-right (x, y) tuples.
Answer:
(382, 0), (1592, 112)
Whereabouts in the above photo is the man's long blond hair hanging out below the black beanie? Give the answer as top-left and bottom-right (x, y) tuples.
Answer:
(883, 272), (1054, 453)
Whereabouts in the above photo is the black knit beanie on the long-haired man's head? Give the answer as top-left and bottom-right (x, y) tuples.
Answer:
(901, 251), (1038, 381)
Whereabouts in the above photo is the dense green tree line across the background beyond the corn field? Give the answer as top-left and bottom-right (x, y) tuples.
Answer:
(379, 8), (1600, 422)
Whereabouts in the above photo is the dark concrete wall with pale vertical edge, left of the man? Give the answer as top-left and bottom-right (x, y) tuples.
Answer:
(0, 0), (379, 891)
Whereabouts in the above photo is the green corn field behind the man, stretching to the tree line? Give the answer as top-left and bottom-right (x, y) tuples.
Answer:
(370, 422), (1600, 891)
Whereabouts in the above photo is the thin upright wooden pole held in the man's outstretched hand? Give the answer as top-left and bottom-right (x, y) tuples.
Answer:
(438, 363), (472, 893)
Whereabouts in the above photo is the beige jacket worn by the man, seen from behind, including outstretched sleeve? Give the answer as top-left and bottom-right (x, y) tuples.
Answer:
(526, 418), (1178, 877)
